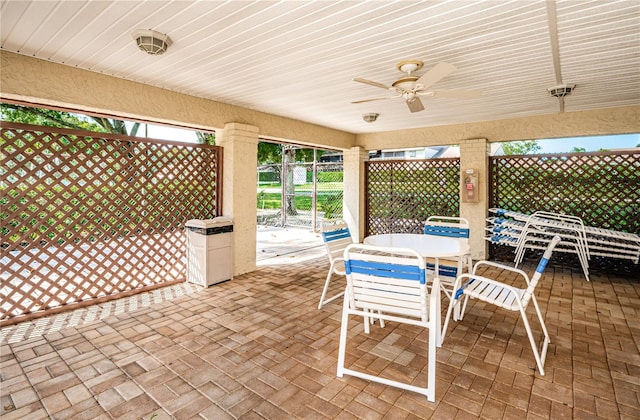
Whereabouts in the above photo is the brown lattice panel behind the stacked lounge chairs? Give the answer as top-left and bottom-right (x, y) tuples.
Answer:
(489, 152), (640, 233)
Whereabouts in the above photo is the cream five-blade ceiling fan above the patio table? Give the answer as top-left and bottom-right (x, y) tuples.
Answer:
(351, 60), (480, 112)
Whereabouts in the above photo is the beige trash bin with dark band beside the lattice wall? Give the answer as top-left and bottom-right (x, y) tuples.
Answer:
(185, 216), (233, 287)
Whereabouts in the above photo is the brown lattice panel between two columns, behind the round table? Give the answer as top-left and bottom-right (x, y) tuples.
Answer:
(365, 159), (460, 235)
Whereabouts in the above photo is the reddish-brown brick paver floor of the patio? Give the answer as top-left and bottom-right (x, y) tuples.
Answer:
(0, 257), (640, 419)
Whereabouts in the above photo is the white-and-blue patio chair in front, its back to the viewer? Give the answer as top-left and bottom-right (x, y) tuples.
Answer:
(337, 244), (440, 401)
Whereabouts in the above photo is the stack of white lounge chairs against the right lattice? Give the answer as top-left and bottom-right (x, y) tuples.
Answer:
(485, 208), (640, 280)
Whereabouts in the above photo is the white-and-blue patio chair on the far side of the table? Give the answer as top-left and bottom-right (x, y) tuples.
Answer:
(424, 216), (473, 299)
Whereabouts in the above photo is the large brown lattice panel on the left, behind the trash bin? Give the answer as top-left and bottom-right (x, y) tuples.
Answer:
(0, 122), (222, 321)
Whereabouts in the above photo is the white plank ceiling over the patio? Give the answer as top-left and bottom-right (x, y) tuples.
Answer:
(0, 0), (640, 133)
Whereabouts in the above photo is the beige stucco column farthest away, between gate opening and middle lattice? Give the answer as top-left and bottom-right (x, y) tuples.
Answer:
(342, 147), (369, 242)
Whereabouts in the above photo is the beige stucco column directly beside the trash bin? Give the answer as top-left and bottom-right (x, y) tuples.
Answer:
(216, 123), (258, 275)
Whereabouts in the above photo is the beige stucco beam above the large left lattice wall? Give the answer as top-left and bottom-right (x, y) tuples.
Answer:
(0, 51), (355, 149)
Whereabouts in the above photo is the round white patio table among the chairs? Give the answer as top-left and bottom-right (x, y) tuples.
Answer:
(364, 233), (470, 347)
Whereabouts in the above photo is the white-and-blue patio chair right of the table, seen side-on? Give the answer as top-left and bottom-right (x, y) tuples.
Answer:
(442, 236), (560, 376)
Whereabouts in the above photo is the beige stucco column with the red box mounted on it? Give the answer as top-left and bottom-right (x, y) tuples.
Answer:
(460, 139), (489, 260)
